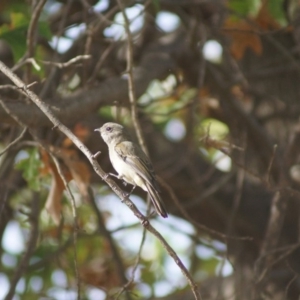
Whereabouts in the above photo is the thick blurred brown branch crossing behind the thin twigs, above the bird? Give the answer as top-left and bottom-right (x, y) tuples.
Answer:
(0, 53), (173, 127)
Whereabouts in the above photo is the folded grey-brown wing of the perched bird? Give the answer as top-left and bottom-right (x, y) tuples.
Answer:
(115, 141), (158, 189)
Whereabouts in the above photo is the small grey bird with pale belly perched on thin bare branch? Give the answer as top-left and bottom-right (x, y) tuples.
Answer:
(95, 122), (168, 218)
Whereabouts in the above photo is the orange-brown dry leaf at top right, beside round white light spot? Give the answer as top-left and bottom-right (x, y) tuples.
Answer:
(225, 19), (263, 60)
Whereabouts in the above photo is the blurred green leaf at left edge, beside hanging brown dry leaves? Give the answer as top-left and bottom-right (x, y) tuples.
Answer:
(16, 148), (42, 191)
